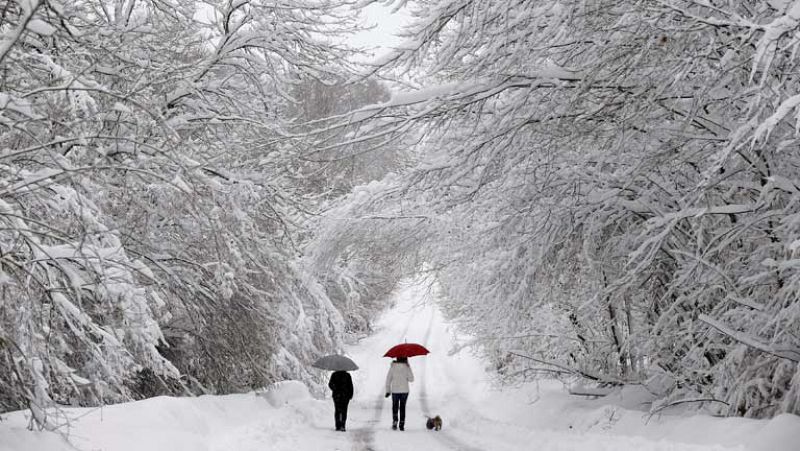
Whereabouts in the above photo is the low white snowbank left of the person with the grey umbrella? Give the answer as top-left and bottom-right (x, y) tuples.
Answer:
(0, 381), (344, 451)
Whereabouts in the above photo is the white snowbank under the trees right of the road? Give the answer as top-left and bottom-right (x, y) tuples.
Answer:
(472, 381), (800, 451)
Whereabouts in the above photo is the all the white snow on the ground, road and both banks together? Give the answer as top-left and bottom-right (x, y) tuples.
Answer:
(0, 283), (800, 451)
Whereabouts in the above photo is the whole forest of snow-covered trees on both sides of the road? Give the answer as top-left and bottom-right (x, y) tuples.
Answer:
(0, 0), (800, 427)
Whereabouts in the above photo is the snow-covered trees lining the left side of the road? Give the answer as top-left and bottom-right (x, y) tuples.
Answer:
(0, 0), (390, 427)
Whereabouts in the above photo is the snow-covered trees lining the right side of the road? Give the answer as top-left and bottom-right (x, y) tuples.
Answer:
(312, 0), (800, 417)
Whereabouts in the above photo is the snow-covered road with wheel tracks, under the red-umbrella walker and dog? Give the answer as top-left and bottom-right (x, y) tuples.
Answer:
(332, 286), (737, 451)
